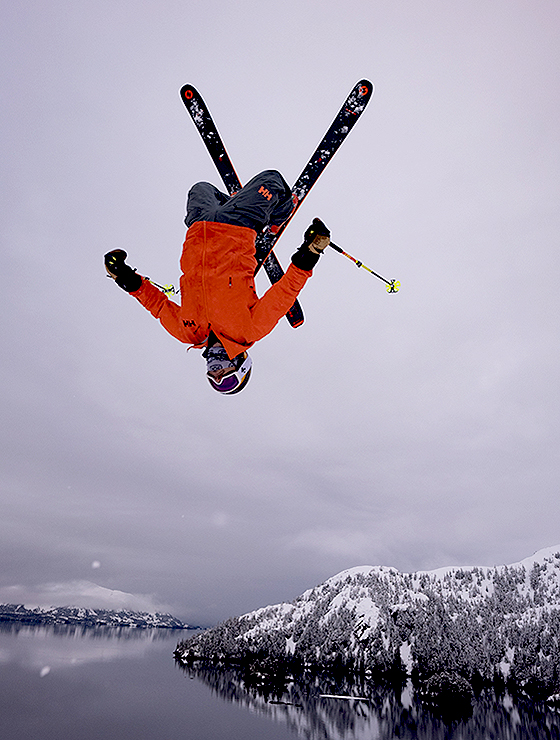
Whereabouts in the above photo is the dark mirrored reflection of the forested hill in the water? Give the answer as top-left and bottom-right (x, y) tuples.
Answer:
(177, 666), (560, 740)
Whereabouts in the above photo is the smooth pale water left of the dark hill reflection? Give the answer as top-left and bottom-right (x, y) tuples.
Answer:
(0, 628), (293, 740)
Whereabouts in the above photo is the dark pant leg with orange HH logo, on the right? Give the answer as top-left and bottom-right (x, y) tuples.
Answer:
(215, 170), (294, 232)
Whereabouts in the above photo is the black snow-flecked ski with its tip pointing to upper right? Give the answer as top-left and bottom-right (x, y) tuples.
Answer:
(256, 80), (374, 272)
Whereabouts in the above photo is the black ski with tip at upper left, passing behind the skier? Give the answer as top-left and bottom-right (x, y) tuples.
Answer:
(181, 85), (304, 328)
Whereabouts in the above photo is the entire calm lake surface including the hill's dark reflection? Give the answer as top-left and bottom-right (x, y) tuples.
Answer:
(0, 628), (560, 740)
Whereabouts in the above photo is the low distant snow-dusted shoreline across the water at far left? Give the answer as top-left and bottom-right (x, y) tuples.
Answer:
(0, 604), (188, 629)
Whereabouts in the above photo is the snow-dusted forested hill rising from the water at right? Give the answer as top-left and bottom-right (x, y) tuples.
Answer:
(176, 545), (560, 696)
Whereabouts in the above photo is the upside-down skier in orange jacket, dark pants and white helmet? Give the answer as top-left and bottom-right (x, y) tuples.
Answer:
(105, 170), (330, 394)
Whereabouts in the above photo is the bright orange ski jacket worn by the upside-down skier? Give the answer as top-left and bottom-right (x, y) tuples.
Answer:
(132, 221), (312, 359)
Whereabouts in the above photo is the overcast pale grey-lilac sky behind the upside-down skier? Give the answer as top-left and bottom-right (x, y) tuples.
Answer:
(0, 0), (560, 623)
